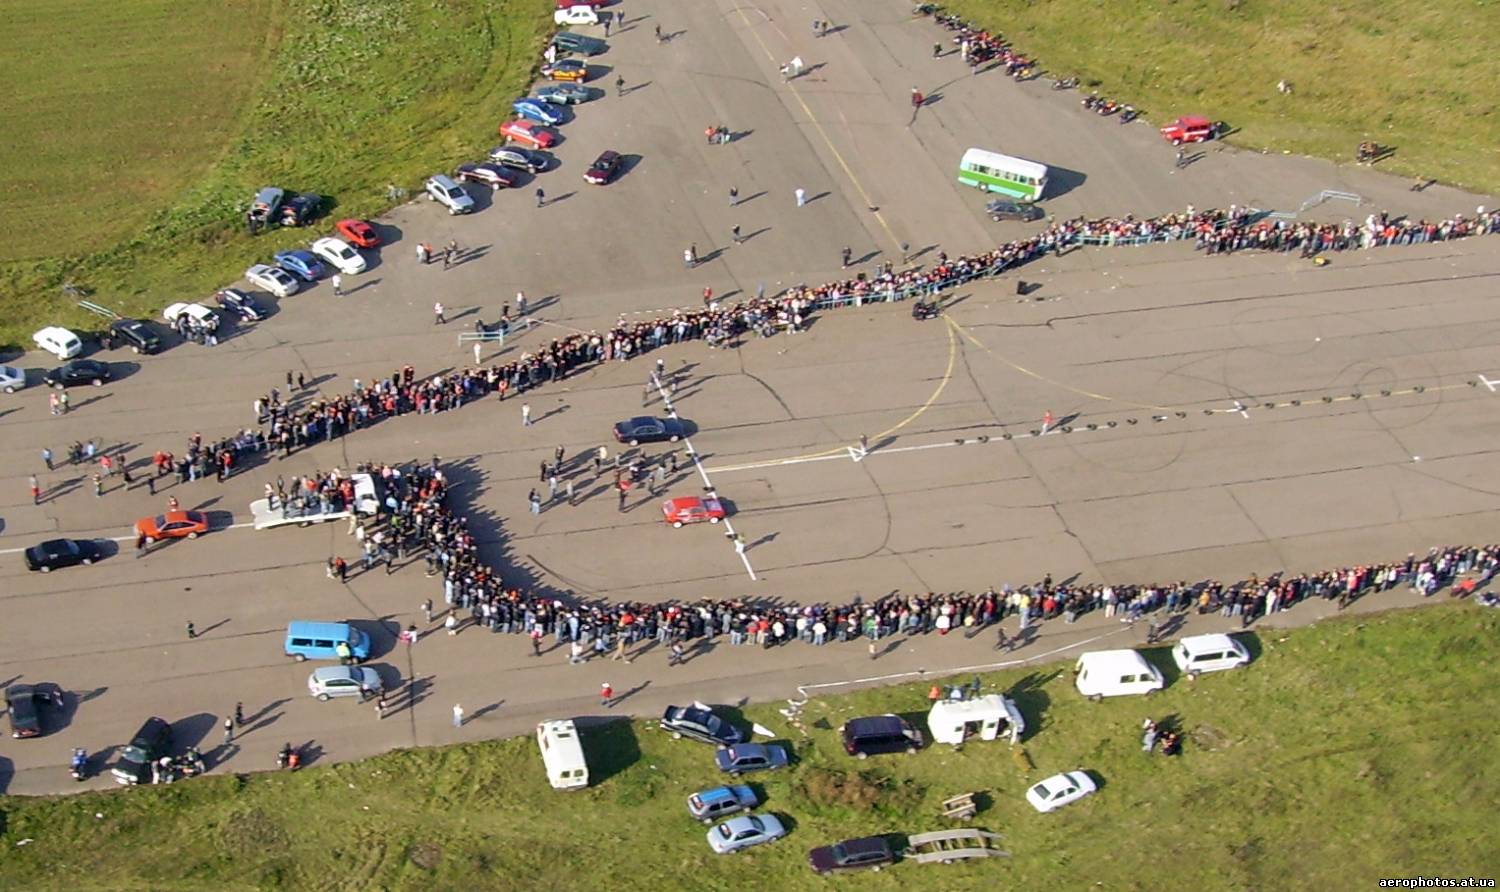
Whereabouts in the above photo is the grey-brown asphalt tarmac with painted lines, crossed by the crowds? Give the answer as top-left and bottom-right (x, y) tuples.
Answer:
(0, 1), (1500, 793)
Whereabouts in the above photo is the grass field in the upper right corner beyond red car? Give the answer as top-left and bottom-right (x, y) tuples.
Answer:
(944, 0), (1500, 193)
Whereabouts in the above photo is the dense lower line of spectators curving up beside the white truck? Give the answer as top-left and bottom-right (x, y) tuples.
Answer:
(356, 460), (1500, 661)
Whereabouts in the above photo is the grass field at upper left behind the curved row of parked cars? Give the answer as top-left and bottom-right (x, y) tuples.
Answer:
(0, 0), (554, 353)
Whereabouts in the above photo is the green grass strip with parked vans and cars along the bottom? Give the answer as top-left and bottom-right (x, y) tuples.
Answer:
(0, 604), (1500, 892)
